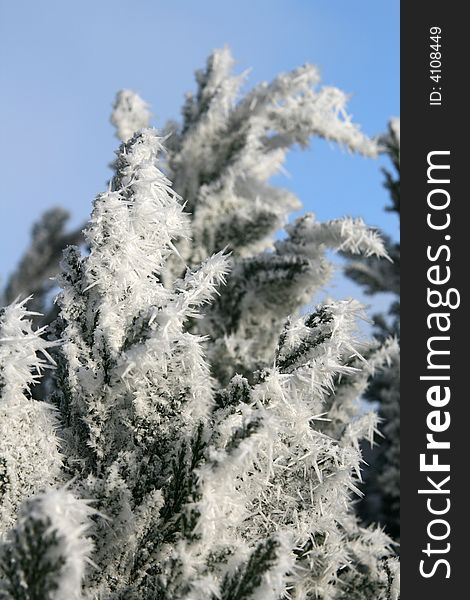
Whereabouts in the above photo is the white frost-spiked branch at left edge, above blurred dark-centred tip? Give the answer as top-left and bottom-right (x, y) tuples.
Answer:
(0, 300), (62, 537)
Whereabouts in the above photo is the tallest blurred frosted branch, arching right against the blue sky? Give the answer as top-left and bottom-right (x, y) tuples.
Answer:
(112, 48), (378, 264)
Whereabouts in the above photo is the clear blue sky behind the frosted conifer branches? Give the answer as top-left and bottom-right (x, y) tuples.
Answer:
(0, 0), (399, 314)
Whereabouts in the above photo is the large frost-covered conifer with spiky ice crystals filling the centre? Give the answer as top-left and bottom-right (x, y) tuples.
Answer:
(0, 51), (399, 600)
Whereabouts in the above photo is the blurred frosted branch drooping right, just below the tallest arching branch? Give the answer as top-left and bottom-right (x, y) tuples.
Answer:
(203, 214), (387, 382)
